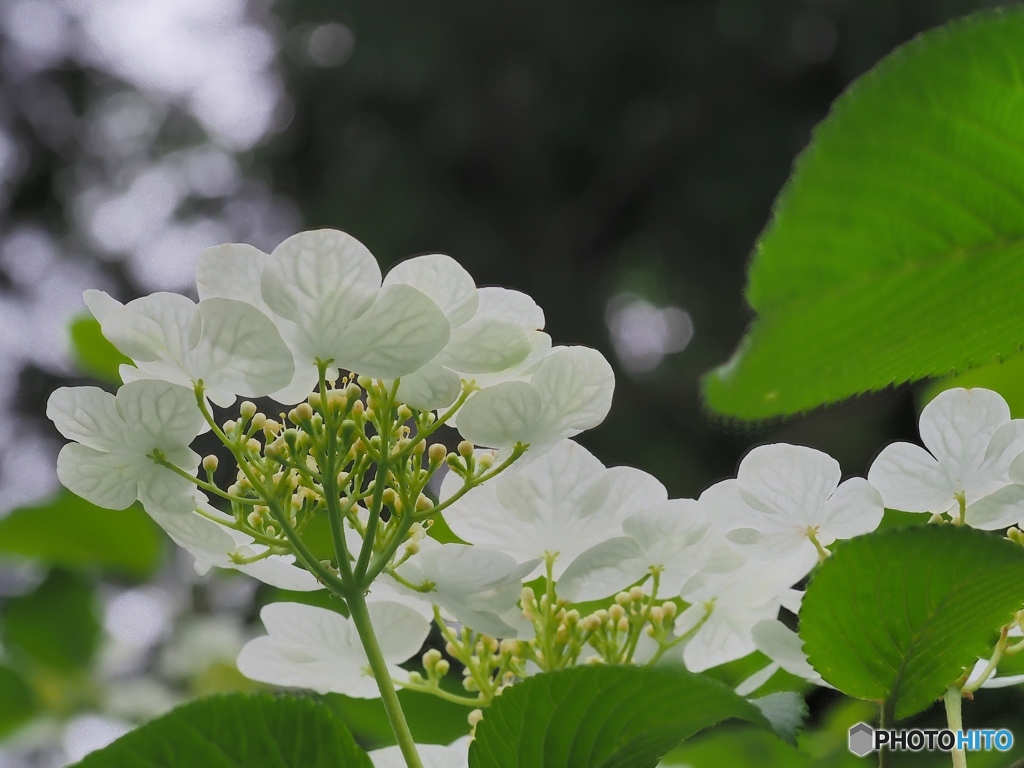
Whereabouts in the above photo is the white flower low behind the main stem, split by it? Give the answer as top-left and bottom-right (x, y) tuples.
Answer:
(239, 602), (430, 698)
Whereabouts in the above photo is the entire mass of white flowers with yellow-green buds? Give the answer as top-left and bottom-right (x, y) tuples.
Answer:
(47, 225), (1024, 765)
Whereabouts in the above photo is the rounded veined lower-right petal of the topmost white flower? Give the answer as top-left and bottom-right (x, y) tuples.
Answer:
(330, 285), (451, 379)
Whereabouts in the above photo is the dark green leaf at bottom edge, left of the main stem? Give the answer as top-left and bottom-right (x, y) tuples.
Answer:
(76, 693), (372, 768)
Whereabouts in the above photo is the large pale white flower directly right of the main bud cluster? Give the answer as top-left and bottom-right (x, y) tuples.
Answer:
(440, 440), (668, 579)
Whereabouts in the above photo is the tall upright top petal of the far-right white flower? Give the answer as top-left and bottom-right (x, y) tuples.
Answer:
(921, 387), (1010, 487)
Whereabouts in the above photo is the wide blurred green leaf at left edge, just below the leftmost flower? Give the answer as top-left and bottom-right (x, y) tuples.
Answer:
(0, 490), (164, 579)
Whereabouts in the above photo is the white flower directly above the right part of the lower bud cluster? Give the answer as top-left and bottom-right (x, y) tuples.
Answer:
(558, 499), (716, 602)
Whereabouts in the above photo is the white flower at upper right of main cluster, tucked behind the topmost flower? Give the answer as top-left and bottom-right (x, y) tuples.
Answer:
(384, 254), (550, 410)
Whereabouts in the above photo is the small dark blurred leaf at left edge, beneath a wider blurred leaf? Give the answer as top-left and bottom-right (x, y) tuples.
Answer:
(0, 570), (100, 673)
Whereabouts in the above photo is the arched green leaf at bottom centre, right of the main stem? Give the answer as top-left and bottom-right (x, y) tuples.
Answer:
(469, 666), (769, 768)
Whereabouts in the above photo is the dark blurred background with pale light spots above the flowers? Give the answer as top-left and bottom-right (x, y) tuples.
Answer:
(0, 0), (1011, 765)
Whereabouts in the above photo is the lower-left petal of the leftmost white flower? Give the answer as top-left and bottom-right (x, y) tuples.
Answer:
(57, 442), (150, 509)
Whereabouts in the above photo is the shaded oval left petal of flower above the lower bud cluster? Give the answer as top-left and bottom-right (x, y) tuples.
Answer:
(558, 537), (647, 602)
